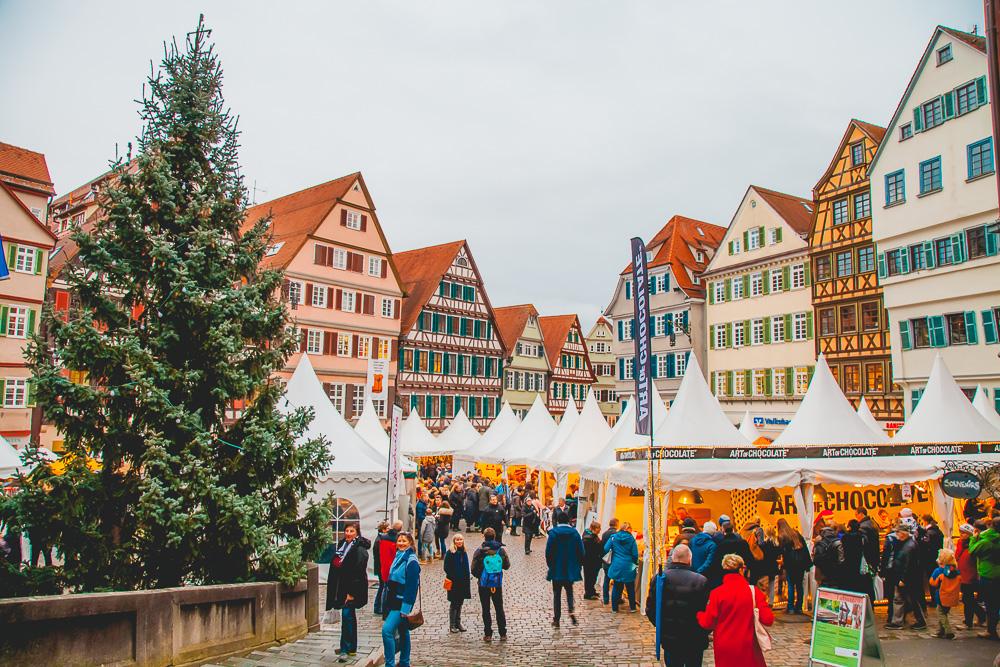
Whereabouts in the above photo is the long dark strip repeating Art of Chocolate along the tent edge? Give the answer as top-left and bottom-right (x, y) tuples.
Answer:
(615, 442), (984, 461)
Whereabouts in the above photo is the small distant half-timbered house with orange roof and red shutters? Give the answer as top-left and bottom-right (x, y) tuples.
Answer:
(538, 315), (597, 417)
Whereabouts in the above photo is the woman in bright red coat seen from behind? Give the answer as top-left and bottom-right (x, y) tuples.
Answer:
(698, 554), (774, 667)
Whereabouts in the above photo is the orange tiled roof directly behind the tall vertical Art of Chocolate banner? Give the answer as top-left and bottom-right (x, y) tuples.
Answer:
(622, 215), (726, 296)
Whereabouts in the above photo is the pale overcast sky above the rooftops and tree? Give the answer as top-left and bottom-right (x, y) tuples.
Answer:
(0, 0), (983, 328)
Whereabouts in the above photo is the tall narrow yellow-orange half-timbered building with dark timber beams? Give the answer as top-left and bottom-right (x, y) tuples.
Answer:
(809, 119), (903, 428)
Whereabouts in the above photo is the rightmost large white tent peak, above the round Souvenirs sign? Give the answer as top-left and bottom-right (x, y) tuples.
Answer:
(893, 354), (1000, 443)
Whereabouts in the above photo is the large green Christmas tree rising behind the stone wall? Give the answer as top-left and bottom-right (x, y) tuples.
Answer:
(7, 22), (330, 590)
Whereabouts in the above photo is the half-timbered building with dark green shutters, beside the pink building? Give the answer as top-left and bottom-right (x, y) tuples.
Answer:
(395, 240), (506, 433)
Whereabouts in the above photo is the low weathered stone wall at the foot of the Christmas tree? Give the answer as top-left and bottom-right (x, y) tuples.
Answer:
(0, 565), (319, 667)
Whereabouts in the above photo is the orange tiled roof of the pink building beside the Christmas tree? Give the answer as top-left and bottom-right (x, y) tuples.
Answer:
(243, 172), (361, 268)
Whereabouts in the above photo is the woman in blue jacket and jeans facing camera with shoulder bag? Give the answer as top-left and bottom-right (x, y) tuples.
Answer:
(382, 533), (420, 667)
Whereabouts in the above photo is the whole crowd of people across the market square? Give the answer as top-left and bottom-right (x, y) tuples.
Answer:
(326, 468), (1000, 667)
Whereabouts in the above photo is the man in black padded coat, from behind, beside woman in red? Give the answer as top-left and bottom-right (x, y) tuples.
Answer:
(646, 544), (708, 667)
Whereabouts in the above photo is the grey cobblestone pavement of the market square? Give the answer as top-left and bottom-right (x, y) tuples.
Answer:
(215, 534), (1000, 667)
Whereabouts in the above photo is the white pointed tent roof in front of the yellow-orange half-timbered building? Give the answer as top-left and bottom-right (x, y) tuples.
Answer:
(773, 354), (889, 447)
